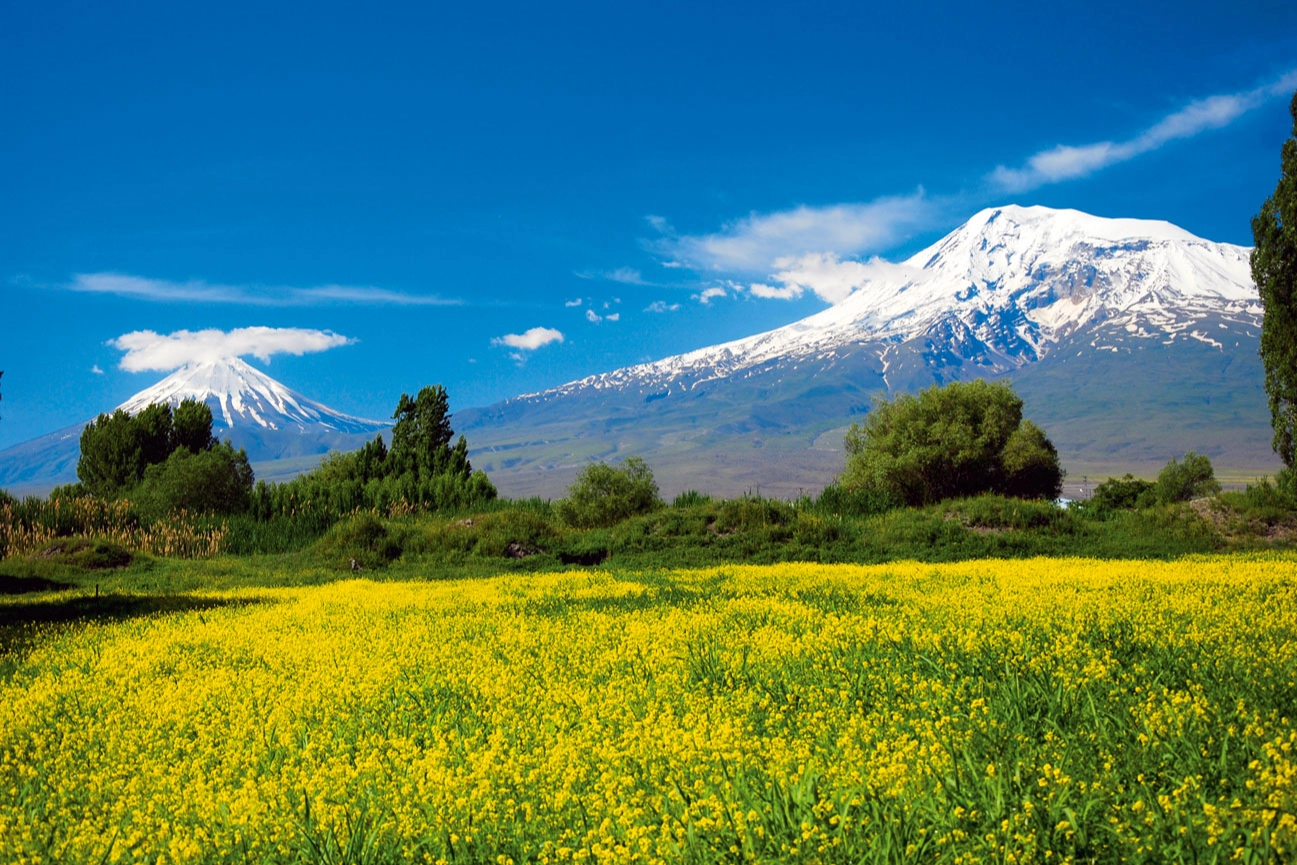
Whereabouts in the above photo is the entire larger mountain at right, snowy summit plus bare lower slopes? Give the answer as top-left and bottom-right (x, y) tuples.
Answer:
(460, 206), (1272, 494)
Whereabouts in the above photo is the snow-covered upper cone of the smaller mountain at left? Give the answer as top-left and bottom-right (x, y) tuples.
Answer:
(118, 358), (390, 433)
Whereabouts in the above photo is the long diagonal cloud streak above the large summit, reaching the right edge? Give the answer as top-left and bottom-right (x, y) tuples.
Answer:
(990, 70), (1297, 192)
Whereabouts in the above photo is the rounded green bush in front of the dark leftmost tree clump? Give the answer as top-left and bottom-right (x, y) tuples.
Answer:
(132, 442), (253, 519)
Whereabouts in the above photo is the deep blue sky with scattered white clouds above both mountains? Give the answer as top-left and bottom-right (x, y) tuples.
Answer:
(0, 0), (1297, 446)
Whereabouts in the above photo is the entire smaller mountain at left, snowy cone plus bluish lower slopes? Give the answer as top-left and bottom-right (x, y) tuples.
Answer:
(0, 358), (392, 494)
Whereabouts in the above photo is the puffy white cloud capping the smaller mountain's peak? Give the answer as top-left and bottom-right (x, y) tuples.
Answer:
(108, 327), (355, 372)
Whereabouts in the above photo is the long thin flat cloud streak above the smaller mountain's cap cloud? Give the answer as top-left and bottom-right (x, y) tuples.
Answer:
(67, 272), (462, 306)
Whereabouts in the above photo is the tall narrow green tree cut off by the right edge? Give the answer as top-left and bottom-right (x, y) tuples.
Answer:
(1252, 93), (1297, 468)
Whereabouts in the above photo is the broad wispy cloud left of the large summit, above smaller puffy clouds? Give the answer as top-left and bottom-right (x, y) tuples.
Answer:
(652, 189), (938, 274)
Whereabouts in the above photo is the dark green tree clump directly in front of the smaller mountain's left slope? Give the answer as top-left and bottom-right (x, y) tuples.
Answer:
(77, 399), (215, 498)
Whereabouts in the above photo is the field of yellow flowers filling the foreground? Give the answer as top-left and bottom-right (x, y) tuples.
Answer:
(0, 555), (1297, 862)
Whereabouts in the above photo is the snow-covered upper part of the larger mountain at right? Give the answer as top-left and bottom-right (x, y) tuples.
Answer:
(519, 206), (1261, 399)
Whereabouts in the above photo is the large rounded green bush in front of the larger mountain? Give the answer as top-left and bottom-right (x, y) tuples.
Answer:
(839, 379), (1062, 504)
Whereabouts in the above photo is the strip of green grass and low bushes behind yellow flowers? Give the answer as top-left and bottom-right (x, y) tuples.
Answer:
(0, 493), (1291, 601)
